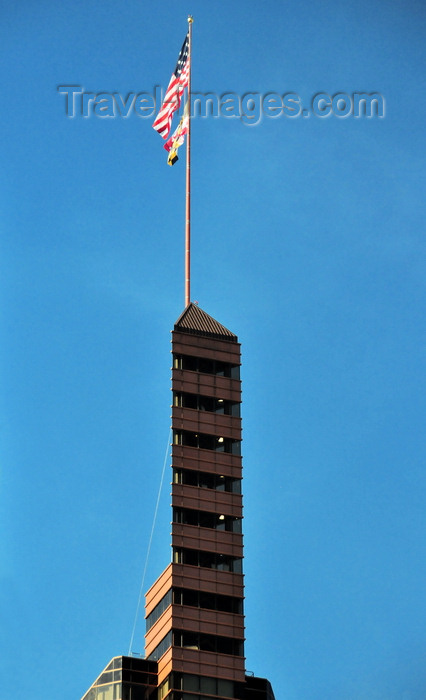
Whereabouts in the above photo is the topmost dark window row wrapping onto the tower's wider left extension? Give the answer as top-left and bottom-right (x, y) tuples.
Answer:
(146, 588), (243, 632)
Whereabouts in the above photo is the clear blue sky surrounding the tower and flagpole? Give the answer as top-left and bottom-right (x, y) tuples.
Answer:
(0, 0), (426, 700)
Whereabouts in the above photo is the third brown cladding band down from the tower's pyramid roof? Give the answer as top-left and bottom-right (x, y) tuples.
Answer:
(172, 406), (241, 440)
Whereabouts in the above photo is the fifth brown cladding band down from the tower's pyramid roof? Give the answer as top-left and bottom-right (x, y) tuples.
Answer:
(172, 484), (243, 518)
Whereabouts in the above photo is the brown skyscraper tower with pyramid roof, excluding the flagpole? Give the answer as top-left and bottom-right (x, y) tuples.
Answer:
(83, 303), (274, 700)
